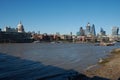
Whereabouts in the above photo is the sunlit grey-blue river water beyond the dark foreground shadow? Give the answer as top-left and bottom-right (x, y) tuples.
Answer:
(0, 43), (120, 72)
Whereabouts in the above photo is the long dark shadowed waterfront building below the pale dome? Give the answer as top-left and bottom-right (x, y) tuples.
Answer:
(0, 32), (33, 43)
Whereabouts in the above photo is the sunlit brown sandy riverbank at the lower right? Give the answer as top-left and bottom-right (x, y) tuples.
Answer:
(85, 48), (120, 80)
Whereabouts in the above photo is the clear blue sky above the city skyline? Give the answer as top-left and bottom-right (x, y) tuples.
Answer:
(0, 0), (120, 34)
